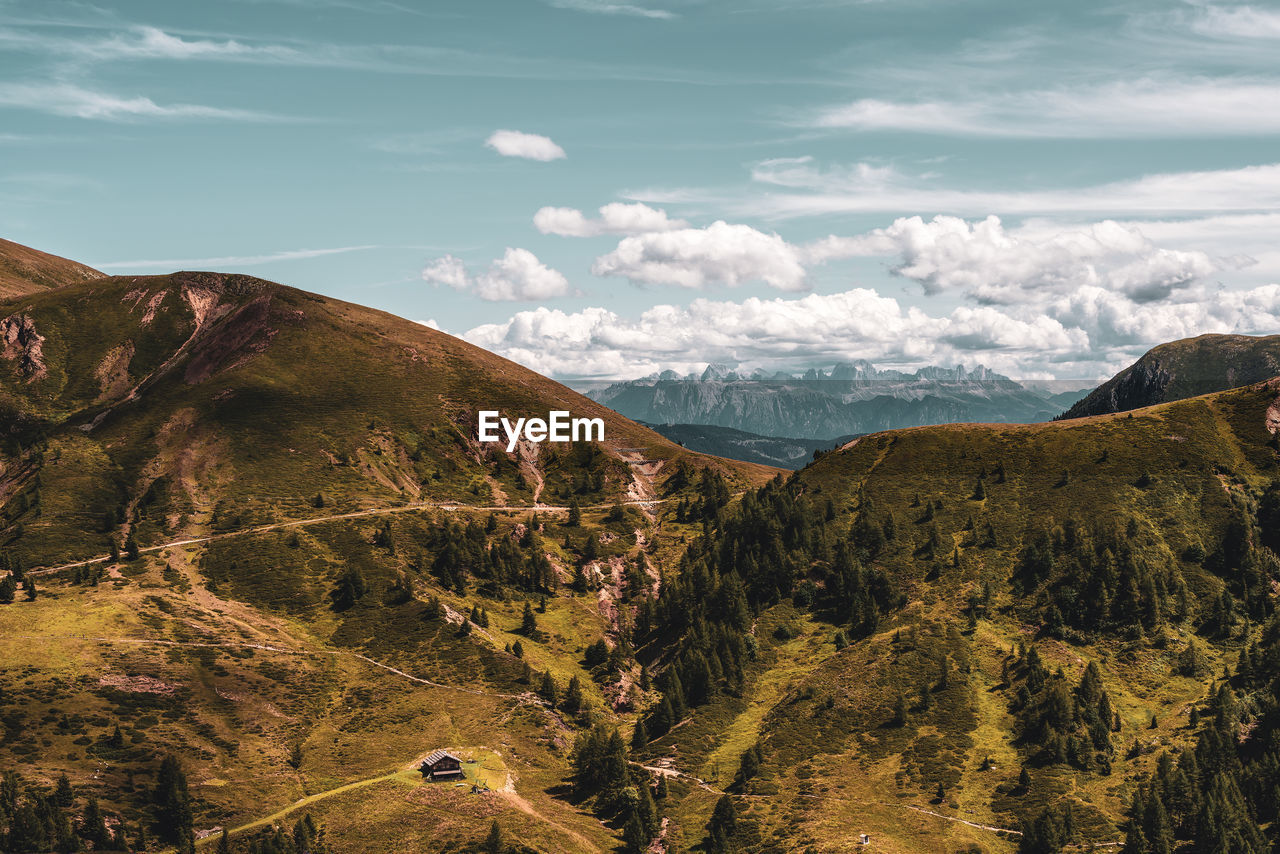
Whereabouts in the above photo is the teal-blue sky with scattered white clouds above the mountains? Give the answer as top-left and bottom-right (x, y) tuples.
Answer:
(0, 0), (1280, 384)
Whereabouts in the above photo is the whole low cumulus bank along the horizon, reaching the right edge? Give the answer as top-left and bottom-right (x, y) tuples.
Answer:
(462, 284), (1280, 380)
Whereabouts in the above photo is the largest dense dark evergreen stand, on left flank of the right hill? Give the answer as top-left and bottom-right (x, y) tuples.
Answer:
(635, 474), (904, 737)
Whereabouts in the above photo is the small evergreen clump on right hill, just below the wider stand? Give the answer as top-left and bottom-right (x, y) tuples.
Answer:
(1011, 647), (1119, 775)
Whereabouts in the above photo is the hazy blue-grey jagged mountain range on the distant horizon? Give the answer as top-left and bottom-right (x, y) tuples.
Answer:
(586, 361), (1089, 442)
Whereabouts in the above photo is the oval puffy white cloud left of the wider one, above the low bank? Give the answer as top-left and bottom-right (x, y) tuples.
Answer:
(591, 220), (806, 291)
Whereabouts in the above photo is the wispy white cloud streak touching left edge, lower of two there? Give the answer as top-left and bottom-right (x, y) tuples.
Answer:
(0, 83), (275, 122)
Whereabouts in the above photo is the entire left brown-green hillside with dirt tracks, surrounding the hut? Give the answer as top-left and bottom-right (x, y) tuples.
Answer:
(0, 263), (776, 851)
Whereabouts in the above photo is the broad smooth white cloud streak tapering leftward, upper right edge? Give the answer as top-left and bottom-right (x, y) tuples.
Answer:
(809, 78), (1280, 138)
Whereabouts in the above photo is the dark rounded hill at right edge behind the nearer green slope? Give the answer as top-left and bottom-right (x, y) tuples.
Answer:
(1062, 335), (1280, 419)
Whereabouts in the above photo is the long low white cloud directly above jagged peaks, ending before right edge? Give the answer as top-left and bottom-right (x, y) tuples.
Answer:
(463, 288), (1088, 378)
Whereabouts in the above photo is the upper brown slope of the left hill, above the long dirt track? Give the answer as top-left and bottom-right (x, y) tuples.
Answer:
(0, 273), (774, 565)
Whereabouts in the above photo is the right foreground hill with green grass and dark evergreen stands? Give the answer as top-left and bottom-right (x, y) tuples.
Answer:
(635, 380), (1280, 854)
